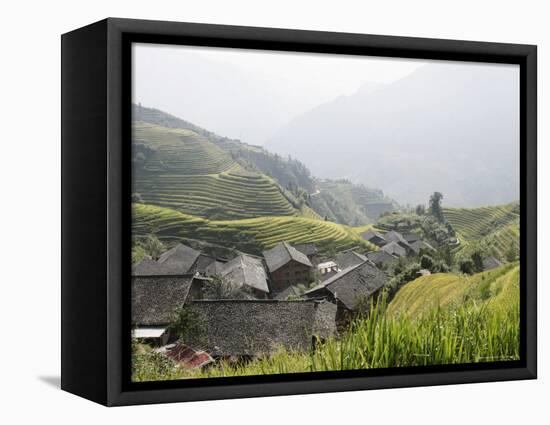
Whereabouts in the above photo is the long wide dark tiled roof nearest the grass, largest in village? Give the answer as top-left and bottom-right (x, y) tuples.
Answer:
(187, 300), (336, 356)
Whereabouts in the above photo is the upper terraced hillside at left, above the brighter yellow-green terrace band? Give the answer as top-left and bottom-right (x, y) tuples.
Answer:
(132, 123), (298, 219)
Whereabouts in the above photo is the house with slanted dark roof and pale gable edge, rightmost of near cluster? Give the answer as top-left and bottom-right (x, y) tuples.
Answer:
(304, 261), (388, 324)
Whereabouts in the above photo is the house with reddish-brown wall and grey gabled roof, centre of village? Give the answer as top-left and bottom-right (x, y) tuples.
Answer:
(263, 242), (313, 293)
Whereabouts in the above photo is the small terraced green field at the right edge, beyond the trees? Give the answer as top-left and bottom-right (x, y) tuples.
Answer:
(443, 202), (519, 258)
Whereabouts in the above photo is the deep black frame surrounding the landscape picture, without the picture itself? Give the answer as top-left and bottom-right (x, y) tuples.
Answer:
(61, 18), (537, 406)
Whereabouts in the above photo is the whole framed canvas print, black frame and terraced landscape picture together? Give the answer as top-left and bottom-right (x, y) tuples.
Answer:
(62, 19), (536, 405)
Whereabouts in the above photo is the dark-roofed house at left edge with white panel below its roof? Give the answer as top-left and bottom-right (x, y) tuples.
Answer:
(131, 275), (204, 345)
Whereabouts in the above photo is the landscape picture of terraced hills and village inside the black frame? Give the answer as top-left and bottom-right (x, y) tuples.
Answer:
(131, 44), (520, 381)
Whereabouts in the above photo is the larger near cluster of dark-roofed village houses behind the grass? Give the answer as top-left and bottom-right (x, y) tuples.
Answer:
(132, 242), (395, 366)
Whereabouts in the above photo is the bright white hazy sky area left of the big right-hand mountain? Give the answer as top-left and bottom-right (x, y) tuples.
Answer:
(133, 44), (426, 144)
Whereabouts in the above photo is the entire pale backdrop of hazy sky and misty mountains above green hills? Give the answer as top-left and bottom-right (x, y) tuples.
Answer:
(133, 44), (519, 206)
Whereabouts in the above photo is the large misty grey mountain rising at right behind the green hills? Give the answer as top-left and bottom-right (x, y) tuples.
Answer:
(266, 62), (519, 207)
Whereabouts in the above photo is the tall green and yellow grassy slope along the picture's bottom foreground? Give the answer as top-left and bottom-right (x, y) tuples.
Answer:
(133, 265), (519, 381)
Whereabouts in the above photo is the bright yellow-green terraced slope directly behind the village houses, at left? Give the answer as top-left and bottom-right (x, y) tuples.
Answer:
(132, 204), (375, 254)
